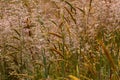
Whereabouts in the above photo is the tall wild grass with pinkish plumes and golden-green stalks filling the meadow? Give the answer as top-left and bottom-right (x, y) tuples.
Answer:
(0, 0), (120, 80)
